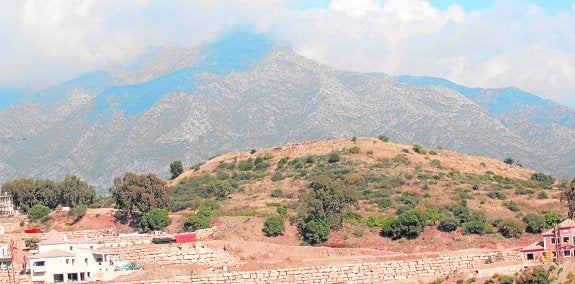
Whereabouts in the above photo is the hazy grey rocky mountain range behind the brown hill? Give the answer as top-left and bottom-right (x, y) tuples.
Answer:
(0, 30), (575, 191)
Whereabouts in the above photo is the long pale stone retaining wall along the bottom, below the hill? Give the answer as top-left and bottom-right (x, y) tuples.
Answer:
(113, 252), (520, 284)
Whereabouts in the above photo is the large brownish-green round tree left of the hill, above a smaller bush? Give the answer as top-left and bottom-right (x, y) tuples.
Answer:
(110, 172), (170, 215)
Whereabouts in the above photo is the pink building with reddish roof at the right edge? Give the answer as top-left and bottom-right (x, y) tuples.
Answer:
(520, 219), (575, 260)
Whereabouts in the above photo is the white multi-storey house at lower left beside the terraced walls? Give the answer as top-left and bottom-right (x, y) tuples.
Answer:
(30, 235), (121, 283)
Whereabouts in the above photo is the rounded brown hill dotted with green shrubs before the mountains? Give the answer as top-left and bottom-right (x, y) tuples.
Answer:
(169, 137), (566, 252)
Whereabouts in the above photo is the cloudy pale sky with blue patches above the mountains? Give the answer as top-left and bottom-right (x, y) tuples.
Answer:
(0, 0), (575, 109)
